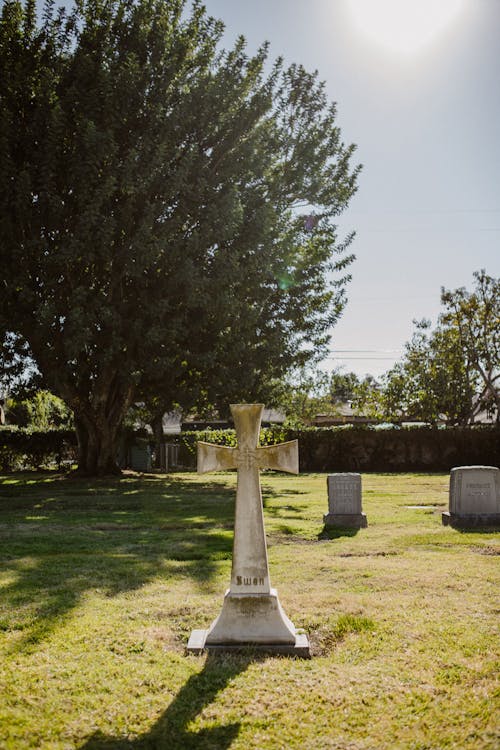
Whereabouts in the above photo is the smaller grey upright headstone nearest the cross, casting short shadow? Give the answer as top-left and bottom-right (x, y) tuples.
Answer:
(323, 473), (368, 529)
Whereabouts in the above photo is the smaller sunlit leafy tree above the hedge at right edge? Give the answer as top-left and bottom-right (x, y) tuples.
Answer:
(363, 271), (500, 425)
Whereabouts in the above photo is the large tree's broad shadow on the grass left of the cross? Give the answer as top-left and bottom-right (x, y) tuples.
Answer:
(0, 477), (234, 651)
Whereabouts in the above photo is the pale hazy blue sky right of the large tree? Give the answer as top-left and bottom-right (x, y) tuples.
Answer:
(204, 0), (500, 377)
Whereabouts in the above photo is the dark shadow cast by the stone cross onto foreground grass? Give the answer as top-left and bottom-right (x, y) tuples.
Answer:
(80, 654), (253, 750)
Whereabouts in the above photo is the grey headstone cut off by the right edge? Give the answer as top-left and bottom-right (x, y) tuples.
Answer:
(442, 466), (500, 528)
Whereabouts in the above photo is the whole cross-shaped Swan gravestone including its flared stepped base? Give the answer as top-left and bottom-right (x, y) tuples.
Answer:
(187, 404), (309, 657)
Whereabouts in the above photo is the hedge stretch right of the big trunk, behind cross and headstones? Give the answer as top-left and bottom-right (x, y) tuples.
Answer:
(171, 425), (500, 472)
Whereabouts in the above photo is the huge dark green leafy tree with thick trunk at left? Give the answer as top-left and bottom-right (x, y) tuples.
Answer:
(0, 0), (359, 474)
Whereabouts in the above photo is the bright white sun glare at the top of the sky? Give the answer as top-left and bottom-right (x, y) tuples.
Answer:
(348, 0), (465, 54)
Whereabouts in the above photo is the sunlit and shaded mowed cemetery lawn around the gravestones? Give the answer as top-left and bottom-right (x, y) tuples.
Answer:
(0, 473), (500, 750)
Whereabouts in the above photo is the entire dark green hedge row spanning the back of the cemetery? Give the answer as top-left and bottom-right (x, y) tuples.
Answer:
(0, 426), (500, 472)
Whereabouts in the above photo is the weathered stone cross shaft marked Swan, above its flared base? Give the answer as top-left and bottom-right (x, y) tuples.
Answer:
(198, 404), (299, 594)
